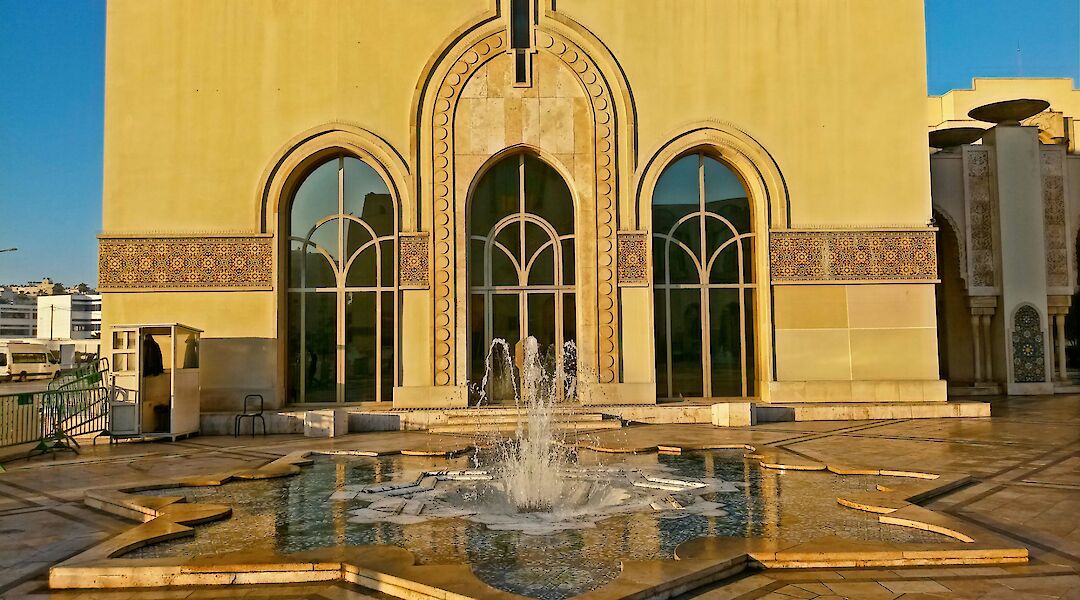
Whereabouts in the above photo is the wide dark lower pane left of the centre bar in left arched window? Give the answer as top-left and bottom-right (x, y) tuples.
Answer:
(296, 291), (337, 403)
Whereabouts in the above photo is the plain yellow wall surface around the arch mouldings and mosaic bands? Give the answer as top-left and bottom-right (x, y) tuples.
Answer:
(103, 0), (937, 407)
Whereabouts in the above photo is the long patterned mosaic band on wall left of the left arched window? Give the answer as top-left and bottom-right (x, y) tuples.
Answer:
(97, 236), (273, 291)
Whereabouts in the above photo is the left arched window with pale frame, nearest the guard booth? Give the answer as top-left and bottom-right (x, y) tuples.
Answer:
(284, 154), (397, 403)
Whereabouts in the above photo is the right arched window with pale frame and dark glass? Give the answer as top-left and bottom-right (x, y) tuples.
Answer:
(652, 152), (755, 398)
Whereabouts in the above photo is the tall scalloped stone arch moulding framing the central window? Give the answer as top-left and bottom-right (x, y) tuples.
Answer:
(415, 3), (632, 386)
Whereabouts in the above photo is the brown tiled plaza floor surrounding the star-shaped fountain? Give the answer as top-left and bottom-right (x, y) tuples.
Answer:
(0, 396), (1080, 600)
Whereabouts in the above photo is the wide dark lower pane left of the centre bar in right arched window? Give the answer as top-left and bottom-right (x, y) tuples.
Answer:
(670, 289), (704, 398)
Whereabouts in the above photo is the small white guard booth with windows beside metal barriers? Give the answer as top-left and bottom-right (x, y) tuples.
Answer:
(109, 323), (202, 440)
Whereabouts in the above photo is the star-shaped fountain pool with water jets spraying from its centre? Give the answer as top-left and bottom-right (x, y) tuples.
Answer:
(118, 338), (954, 600)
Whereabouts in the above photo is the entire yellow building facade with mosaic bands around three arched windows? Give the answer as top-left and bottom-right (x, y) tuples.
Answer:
(100, 0), (945, 411)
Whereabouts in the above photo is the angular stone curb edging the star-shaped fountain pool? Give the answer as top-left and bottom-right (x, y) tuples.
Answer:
(50, 445), (1028, 600)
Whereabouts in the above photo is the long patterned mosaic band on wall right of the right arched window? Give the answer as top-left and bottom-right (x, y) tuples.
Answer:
(769, 230), (937, 283)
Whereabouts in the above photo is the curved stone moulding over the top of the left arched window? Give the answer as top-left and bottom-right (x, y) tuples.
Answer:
(256, 123), (417, 234)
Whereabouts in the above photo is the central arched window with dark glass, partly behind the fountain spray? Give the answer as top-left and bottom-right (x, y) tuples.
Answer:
(469, 153), (577, 401)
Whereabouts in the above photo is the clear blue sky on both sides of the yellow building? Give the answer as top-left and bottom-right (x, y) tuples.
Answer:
(0, 0), (1080, 284)
